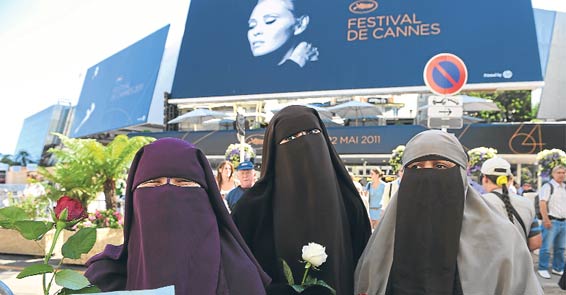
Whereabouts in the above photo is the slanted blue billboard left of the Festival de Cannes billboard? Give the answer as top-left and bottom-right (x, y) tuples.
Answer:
(70, 25), (169, 137)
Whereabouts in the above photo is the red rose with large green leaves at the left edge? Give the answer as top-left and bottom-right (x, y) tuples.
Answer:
(0, 196), (100, 295)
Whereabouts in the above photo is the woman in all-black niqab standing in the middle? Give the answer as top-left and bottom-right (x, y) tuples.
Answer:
(233, 106), (371, 294)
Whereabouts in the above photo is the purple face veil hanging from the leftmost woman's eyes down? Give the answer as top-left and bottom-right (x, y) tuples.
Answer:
(127, 177), (220, 294)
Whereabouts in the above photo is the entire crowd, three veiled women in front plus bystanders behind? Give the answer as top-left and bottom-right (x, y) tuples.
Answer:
(85, 106), (566, 295)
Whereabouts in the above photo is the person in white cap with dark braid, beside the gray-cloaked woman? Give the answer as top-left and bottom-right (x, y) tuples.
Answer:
(481, 157), (542, 251)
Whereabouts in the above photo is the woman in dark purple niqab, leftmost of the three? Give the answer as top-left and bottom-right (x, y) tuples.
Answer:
(85, 138), (270, 295)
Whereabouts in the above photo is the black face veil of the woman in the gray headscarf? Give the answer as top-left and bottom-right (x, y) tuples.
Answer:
(387, 166), (464, 295)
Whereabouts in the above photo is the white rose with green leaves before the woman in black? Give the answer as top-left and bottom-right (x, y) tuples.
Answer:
(267, 243), (336, 295)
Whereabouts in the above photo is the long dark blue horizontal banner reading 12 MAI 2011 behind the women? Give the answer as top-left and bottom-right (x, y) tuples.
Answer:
(134, 124), (566, 156)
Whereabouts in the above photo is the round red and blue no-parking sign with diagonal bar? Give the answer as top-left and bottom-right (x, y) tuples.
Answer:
(423, 53), (468, 96)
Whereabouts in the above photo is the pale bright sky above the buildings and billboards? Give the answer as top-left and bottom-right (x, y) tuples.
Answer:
(0, 0), (566, 154)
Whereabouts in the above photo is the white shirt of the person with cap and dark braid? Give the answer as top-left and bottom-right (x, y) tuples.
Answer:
(482, 189), (535, 239)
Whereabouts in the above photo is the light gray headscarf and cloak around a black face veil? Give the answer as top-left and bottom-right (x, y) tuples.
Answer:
(354, 130), (543, 295)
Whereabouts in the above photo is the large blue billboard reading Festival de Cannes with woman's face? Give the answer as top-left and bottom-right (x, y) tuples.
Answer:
(172, 0), (542, 98)
